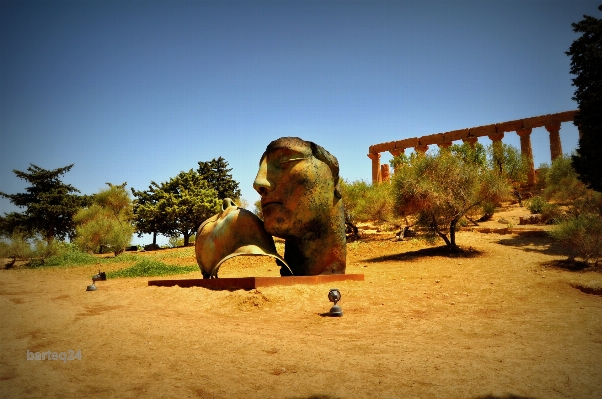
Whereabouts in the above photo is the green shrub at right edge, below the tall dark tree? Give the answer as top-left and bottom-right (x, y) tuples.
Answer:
(551, 213), (602, 264)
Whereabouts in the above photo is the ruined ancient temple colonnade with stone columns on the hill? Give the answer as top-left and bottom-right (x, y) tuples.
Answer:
(368, 110), (581, 185)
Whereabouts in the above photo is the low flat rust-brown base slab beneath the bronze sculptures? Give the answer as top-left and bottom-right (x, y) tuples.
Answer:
(148, 274), (364, 290)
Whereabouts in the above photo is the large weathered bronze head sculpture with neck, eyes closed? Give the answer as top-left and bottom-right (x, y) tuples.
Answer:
(253, 137), (347, 276)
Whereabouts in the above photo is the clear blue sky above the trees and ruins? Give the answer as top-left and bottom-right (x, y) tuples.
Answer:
(0, 0), (601, 247)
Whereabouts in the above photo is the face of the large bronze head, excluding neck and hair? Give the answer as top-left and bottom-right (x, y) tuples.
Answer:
(253, 138), (335, 238)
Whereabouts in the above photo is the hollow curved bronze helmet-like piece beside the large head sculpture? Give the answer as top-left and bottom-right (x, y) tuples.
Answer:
(195, 198), (292, 278)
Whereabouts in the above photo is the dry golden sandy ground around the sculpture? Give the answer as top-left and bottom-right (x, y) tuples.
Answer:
(0, 208), (602, 399)
